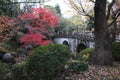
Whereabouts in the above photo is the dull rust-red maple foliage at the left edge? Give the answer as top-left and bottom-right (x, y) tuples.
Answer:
(0, 16), (14, 43)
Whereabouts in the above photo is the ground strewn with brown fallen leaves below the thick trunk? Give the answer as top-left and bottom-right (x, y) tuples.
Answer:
(55, 62), (120, 80)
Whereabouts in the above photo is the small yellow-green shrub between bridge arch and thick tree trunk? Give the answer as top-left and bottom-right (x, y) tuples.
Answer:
(78, 48), (94, 62)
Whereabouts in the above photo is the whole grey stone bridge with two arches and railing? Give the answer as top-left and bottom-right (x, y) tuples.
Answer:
(54, 32), (94, 52)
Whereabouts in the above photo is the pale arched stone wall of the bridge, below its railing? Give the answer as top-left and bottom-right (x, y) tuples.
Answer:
(54, 38), (89, 52)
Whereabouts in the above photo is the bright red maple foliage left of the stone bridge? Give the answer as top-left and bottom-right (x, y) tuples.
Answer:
(18, 7), (58, 45)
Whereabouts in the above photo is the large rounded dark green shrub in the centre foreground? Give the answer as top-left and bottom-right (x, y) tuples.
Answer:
(27, 44), (70, 80)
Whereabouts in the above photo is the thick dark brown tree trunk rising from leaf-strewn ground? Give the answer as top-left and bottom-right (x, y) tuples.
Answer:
(92, 0), (113, 65)
